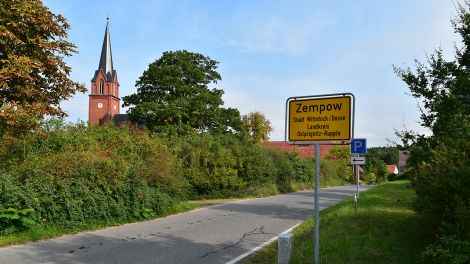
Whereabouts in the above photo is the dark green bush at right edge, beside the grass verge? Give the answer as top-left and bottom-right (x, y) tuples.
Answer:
(406, 122), (470, 263)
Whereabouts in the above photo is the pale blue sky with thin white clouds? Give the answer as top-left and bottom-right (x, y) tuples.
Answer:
(43, 0), (460, 146)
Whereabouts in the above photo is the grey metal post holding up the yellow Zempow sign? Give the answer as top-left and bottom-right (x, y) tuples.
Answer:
(313, 143), (320, 264)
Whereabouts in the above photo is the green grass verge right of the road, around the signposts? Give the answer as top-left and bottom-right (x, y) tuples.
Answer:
(244, 181), (432, 264)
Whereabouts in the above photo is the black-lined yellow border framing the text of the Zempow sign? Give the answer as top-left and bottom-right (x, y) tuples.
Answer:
(285, 93), (355, 144)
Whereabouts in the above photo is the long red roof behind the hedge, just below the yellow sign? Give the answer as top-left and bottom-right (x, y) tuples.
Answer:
(262, 141), (336, 158)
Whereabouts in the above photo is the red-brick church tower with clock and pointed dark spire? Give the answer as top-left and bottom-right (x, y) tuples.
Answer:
(88, 18), (121, 125)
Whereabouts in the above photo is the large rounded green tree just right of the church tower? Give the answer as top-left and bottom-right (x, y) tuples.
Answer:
(123, 50), (241, 132)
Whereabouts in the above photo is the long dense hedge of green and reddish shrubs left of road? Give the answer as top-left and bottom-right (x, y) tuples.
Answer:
(0, 119), (349, 233)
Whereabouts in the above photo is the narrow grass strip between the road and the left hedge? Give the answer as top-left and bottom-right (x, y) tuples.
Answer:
(0, 199), (235, 247)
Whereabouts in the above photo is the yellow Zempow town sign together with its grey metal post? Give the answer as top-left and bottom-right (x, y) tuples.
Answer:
(285, 93), (354, 264)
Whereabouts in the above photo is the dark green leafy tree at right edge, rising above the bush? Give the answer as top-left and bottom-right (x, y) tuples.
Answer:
(394, 1), (470, 169)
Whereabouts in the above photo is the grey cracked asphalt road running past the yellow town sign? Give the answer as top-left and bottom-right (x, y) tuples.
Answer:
(0, 186), (370, 264)
